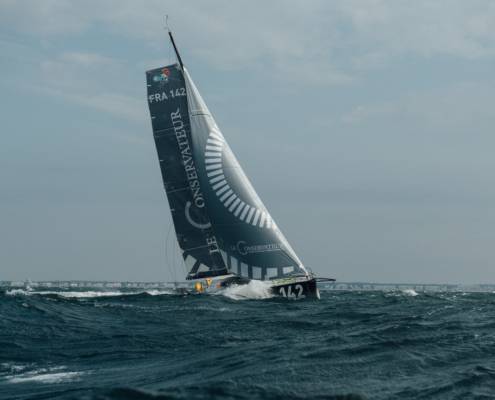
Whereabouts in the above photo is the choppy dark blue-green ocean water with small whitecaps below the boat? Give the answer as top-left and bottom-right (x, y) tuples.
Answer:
(0, 288), (495, 400)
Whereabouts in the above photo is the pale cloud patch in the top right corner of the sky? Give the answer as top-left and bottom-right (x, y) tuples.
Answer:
(339, 0), (495, 59)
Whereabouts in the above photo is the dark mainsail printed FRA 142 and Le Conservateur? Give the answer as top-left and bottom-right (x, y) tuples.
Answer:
(146, 64), (227, 279)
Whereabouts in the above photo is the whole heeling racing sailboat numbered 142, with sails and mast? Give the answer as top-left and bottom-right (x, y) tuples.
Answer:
(146, 30), (330, 299)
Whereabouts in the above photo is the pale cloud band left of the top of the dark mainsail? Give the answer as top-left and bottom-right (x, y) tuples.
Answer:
(0, 40), (147, 122)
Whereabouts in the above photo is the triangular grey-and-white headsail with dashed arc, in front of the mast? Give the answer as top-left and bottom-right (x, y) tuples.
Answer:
(184, 68), (308, 280)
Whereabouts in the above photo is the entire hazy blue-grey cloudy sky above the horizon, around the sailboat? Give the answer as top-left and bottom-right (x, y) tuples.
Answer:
(0, 0), (495, 283)
